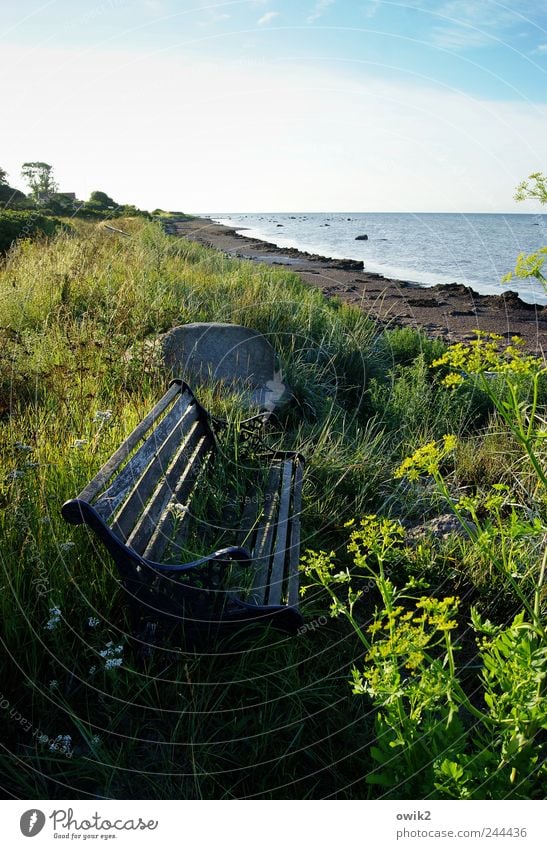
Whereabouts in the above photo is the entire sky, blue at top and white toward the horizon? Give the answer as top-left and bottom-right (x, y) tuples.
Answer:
(0, 0), (547, 212)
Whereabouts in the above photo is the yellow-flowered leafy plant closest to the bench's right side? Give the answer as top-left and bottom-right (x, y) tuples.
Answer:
(302, 515), (488, 798)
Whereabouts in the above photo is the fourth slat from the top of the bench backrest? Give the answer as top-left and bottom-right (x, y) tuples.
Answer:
(127, 422), (210, 554)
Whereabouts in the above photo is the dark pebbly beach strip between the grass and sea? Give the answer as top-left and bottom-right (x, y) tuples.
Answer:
(166, 218), (547, 354)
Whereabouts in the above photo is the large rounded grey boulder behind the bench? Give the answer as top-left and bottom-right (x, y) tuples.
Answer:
(161, 322), (290, 411)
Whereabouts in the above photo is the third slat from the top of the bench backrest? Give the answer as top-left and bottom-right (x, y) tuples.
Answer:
(107, 405), (202, 539)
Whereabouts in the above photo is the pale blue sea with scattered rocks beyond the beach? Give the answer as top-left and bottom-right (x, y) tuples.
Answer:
(209, 212), (547, 304)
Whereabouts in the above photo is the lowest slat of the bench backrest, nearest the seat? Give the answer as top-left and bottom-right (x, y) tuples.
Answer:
(143, 437), (211, 562)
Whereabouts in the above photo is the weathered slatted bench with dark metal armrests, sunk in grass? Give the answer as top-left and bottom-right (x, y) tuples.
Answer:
(62, 380), (304, 640)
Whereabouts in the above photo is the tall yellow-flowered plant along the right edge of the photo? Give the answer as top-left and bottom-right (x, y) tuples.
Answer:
(388, 334), (547, 798)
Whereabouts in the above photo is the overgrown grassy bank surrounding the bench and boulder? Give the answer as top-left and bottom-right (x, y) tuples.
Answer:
(0, 220), (545, 798)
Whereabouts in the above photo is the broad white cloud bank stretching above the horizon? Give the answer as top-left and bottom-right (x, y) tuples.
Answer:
(0, 47), (547, 212)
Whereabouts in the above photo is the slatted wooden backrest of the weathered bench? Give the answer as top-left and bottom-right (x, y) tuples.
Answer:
(62, 380), (215, 561)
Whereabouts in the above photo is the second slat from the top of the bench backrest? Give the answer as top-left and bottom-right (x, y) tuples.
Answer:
(94, 394), (195, 522)
